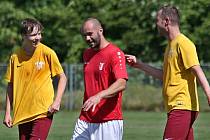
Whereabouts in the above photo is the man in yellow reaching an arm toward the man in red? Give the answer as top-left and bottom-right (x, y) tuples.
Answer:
(126, 6), (210, 140)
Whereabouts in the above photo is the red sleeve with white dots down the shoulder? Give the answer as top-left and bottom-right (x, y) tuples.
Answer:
(111, 50), (128, 80)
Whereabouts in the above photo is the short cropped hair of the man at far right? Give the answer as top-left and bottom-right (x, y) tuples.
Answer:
(158, 5), (180, 25)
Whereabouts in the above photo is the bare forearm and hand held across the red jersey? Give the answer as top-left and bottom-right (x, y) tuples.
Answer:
(82, 79), (126, 111)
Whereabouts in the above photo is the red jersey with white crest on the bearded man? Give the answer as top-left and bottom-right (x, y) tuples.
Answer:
(80, 44), (128, 123)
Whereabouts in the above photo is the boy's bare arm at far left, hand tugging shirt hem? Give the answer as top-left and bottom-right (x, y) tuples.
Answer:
(3, 83), (13, 128)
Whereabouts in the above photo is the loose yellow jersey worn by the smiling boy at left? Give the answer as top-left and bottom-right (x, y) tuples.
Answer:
(5, 43), (63, 125)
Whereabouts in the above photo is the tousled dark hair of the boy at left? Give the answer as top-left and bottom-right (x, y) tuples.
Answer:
(20, 18), (43, 35)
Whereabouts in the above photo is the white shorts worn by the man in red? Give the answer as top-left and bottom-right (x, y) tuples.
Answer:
(71, 119), (123, 140)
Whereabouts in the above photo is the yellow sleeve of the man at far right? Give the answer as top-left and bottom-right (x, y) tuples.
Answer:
(179, 41), (200, 69)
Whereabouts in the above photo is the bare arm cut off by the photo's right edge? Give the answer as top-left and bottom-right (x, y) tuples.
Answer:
(190, 65), (210, 105)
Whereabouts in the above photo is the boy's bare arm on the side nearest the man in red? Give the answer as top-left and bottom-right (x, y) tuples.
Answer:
(48, 73), (67, 114)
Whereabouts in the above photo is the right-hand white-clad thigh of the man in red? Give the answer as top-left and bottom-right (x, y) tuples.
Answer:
(91, 120), (123, 140)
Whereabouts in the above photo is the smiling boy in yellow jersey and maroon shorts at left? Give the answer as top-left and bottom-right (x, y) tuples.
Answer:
(4, 19), (67, 140)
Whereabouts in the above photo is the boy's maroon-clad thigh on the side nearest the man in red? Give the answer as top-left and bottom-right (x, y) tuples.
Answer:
(30, 116), (53, 140)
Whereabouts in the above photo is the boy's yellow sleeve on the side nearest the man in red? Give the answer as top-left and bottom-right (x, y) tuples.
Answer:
(50, 51), (63, 77)
